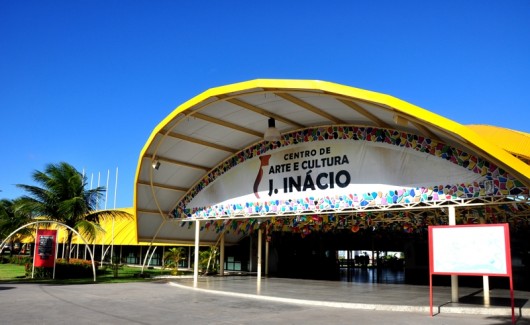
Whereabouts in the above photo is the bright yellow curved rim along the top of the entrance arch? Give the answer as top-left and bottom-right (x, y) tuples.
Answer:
(134, 79), (530, 214)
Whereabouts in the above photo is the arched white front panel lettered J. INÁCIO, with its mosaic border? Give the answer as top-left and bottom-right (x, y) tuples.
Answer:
(173, 126), (528, 218)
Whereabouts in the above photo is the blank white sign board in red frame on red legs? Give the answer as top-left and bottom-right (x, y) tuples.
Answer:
(429, 224), (515, 322)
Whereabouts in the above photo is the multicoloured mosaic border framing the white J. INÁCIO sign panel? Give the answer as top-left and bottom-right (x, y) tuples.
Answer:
(172, 126), (528, 219)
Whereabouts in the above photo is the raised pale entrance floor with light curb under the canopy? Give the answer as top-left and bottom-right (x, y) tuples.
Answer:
(172, 276), (530, 316)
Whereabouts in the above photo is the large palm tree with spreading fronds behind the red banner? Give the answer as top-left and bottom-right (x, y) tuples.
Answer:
(17, 162), (130, 258)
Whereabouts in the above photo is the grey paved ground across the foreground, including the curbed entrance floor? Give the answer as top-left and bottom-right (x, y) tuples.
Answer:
(0, 277), (530, 325)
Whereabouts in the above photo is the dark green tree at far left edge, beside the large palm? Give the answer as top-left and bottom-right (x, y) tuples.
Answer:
(0, 199), (32, 255)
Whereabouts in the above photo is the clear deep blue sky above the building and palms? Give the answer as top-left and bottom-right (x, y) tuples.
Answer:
(0, 0), (530, 207)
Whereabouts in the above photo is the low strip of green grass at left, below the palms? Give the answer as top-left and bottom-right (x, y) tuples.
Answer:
(0, 263), (188, 284)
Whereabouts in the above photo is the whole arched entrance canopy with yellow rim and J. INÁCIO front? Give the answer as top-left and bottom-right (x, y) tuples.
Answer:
(134, 80), (530, 244)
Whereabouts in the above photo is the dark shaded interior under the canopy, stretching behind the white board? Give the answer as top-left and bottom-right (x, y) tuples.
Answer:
(227, 224), (530, 290)
